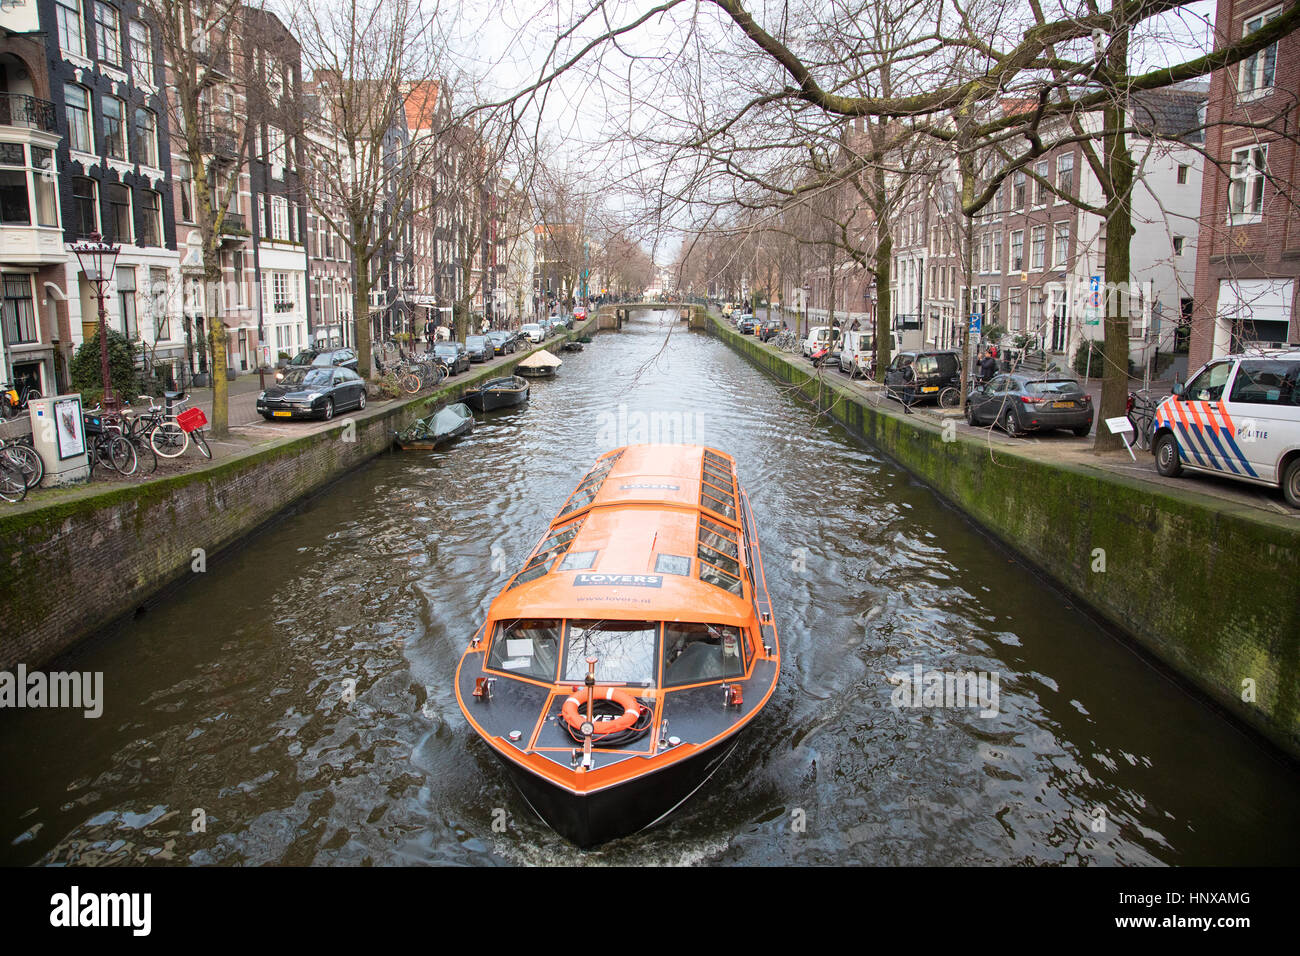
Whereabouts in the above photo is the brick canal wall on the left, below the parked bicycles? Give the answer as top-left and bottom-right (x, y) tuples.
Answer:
(0, 320), (594, 671)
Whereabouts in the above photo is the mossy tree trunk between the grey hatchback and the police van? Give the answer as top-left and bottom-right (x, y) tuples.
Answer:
(1092, 14), (1134, 451)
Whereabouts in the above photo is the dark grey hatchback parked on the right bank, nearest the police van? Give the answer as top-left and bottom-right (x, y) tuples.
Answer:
(966, 373), (1096, 438)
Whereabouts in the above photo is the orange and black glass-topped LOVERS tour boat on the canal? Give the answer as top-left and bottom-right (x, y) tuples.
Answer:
(456, 445), (781, 847)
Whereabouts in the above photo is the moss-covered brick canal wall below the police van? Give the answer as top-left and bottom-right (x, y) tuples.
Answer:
(710, 316), (1300, 757)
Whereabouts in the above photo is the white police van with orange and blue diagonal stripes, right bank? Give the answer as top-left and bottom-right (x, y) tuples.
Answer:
(1151, 347), (1300, 507)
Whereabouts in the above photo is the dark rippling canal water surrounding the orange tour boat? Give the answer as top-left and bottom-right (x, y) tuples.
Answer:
(0, 312), (1300, 865)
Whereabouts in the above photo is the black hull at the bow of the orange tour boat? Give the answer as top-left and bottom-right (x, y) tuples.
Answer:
(497, 734), (740, 849)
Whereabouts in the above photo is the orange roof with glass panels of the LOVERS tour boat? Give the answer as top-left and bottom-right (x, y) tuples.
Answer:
(489, 445), (755, 626)
